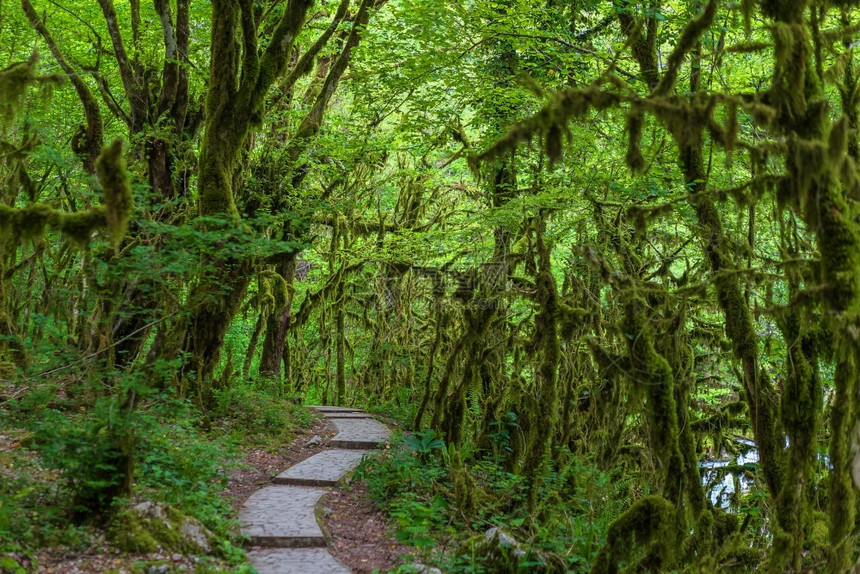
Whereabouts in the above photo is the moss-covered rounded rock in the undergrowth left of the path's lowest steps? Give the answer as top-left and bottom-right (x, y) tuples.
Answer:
(110, 501), (215, 554)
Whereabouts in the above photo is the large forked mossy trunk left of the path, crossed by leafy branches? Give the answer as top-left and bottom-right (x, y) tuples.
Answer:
(175, 0), (313, 396)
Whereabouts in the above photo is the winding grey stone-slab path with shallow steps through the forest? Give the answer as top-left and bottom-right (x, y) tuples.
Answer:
(239, 406), (390, 574)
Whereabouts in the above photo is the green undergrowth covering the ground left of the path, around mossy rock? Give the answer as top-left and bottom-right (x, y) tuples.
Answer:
(0, 373), (311, 572)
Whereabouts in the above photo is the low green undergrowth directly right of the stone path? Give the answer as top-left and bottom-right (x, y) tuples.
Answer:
(356, 433), (641, 574)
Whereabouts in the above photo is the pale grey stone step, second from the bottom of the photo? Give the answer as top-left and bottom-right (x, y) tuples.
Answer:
(239, 485), (328, 548)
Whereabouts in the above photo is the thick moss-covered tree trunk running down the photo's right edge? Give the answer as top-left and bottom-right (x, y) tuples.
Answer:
(761, 0), (860, 573)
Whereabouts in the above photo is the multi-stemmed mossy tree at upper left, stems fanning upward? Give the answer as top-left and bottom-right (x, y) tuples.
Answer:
(26, 0), (199, 366)
